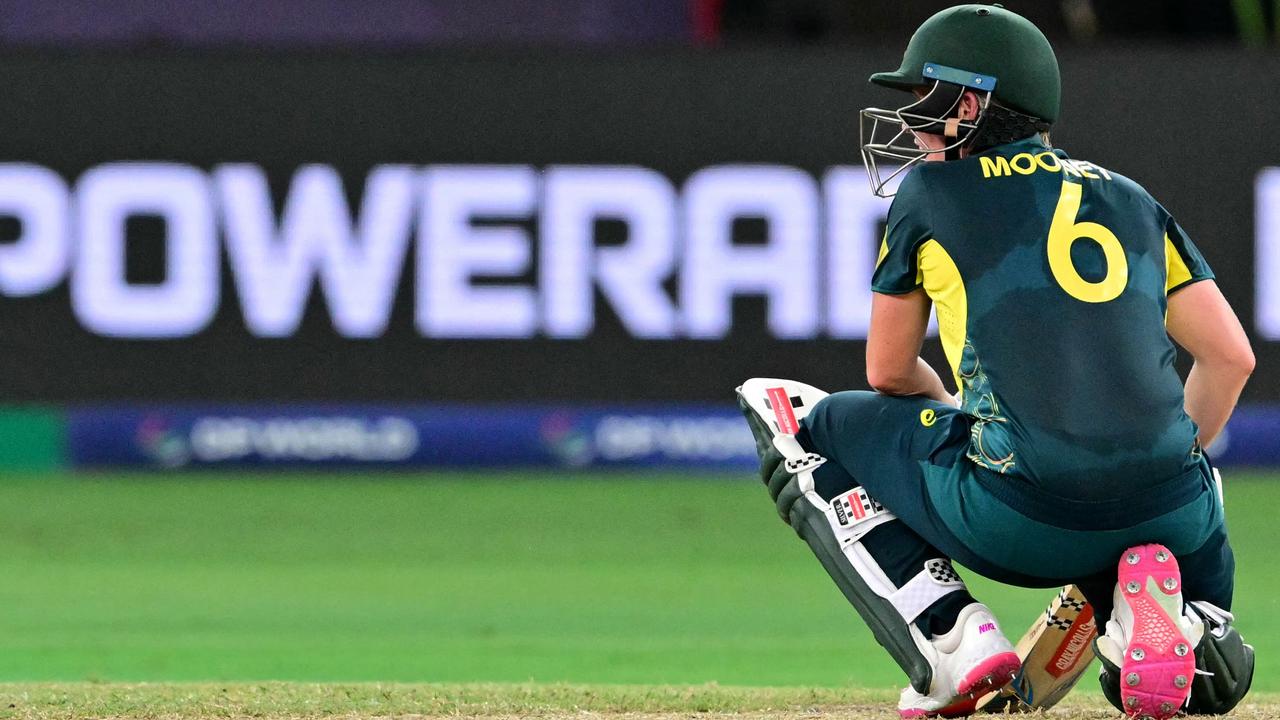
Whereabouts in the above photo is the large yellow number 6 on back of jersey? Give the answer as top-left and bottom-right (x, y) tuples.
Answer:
(1048, 181), (1129, 302)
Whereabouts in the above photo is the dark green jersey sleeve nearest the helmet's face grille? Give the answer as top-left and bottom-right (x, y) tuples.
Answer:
(872, 169), (933, 295)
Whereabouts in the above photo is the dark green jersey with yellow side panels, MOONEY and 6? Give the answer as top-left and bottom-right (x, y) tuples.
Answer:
(872, 138), (1212, 500)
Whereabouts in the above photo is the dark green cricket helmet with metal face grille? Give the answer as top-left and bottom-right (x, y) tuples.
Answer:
(861, 5), (1062, 197)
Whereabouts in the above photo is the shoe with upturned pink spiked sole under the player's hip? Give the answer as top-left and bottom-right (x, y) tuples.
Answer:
(1098, 544), (1204, 720)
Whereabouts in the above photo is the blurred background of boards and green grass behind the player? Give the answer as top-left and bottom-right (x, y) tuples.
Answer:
(0, 0), (1280, 689)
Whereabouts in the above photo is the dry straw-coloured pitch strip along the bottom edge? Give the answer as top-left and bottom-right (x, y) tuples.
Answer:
(0, 683), (1280, 720)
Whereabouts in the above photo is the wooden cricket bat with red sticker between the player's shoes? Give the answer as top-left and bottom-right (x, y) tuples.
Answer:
(978, 585), (1097, 712)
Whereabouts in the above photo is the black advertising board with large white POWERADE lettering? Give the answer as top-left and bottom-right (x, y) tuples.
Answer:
(0, 49), (1280, 405)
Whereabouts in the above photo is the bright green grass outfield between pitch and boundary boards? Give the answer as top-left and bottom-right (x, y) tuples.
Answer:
(0, 473), (1280, 696)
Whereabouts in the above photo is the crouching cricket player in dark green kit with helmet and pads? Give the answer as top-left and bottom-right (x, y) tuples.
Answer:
(739, 5), (1253, 719)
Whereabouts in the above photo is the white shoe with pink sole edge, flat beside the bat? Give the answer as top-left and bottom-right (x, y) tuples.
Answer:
(897, 602), (1021, 717)
